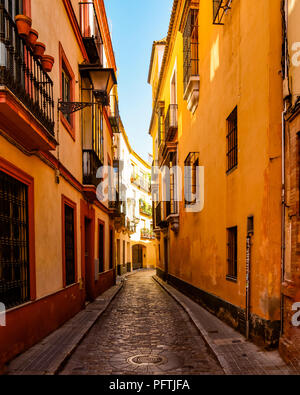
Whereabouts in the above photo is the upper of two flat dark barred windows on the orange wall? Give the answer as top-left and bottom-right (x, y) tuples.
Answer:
(227, 107), (238, 173)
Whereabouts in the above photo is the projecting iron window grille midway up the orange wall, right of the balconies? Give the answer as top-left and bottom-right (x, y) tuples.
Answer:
(184, 152), (199, 206)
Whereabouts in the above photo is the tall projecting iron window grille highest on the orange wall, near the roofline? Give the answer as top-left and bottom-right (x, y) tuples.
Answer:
(183, 9), (199, 91)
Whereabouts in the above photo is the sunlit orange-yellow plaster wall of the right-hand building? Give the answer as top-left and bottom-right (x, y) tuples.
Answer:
(151, 0), (282, 320)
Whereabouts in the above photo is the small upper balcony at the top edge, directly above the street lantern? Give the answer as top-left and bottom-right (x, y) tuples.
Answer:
(79, 2), (103, 67)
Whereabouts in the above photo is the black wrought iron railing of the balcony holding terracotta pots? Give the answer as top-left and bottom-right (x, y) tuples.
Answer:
(0, 4), (54, 136)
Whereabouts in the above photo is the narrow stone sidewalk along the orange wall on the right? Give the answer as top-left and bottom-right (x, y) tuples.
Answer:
(153, 275), (300, 375)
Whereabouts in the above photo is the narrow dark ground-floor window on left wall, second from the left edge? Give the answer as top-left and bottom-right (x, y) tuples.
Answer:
(65, 205), (75, 286)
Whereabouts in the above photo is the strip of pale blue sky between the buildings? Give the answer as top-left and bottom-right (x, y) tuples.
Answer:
(104, 0), (173, 160)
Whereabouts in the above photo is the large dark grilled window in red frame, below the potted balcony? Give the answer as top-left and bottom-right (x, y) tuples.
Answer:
(0, 172), (30, 309)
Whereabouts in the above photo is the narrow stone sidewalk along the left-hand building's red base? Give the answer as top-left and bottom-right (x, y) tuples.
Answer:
(6, 283), (123, 375)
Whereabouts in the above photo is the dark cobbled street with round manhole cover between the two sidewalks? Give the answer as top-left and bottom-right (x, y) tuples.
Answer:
(61, 271), (223, 375)
